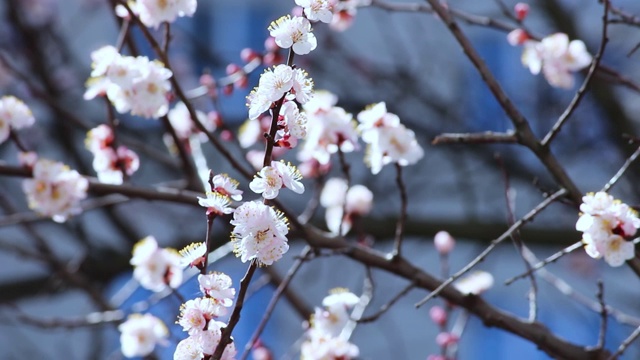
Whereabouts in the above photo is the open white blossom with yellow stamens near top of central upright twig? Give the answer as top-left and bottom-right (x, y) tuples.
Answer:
(269, 15), (318, 55)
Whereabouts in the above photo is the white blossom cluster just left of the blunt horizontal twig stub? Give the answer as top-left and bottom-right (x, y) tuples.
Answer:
(358, 102), (424, 175)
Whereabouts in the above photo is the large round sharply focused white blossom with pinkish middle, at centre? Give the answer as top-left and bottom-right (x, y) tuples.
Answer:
(231, 201), (289, 265)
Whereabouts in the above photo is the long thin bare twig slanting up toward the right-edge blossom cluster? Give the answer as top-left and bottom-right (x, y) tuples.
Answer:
(416, 189), (567, 307)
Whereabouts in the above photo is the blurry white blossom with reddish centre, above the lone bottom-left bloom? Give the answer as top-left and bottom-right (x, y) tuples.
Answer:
(129, 236), (182, 292)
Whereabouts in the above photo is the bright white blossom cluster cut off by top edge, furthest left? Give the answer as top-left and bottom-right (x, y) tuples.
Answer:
(116, 0), (198, 28)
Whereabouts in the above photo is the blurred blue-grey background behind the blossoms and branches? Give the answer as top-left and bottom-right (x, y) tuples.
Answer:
(0, 0), (640, 360)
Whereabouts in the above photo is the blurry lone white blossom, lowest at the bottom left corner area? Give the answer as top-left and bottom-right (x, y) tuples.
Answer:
(118, 314), (169, 358)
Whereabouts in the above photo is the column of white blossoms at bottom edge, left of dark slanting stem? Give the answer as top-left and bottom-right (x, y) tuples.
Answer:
(173, 272), (236, 360)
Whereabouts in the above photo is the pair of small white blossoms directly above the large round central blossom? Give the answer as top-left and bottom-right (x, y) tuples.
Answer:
(249, 161), (304, 199)
